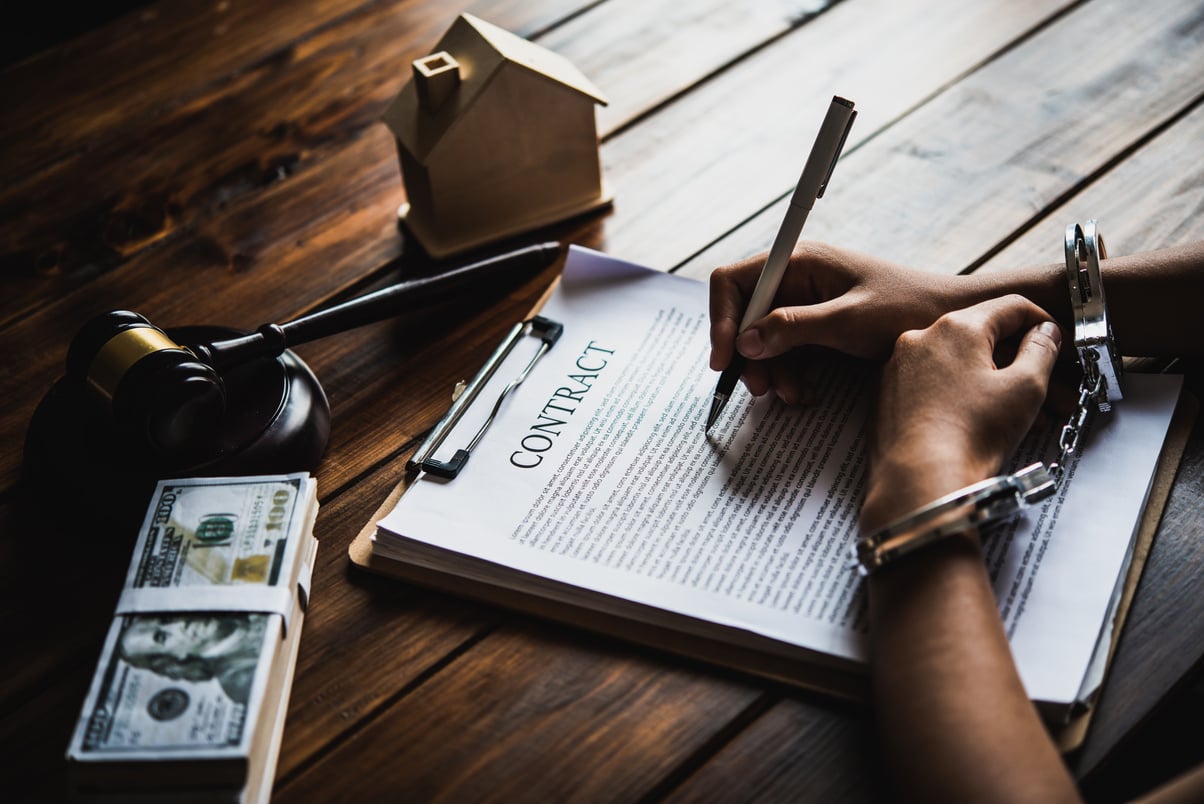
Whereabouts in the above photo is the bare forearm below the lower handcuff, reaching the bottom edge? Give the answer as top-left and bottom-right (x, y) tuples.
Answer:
(869, 534), (1078, 802)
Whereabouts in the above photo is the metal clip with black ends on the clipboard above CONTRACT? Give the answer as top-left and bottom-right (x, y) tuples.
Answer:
(406, 315), (565, 480)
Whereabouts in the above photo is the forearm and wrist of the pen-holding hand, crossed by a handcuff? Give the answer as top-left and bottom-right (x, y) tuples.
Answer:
(954, 242), (1204, 356)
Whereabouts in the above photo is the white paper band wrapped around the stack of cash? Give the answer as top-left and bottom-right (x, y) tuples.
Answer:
(117, 580), (309, 634)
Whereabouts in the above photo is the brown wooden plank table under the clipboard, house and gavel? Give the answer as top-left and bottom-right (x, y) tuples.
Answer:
(0, 0), (1204, 800)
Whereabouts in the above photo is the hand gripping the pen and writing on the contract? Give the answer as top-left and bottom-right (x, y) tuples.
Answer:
(710, 243), (964, 403)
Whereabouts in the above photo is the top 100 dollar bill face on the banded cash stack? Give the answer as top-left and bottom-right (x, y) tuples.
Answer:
(69, 475), (315, 786)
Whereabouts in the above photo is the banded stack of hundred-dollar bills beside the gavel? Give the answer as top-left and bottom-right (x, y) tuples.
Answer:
(67, 473), (318, 802)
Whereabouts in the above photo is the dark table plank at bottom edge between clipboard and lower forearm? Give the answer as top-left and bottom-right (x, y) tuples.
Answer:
(666, 698), (891, 804)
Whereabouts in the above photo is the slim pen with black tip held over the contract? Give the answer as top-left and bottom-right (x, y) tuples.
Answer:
(706, 97), (857, 432)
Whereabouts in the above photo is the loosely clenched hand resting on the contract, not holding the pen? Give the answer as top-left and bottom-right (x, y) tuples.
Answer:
(861, 295), (1062, 532)
